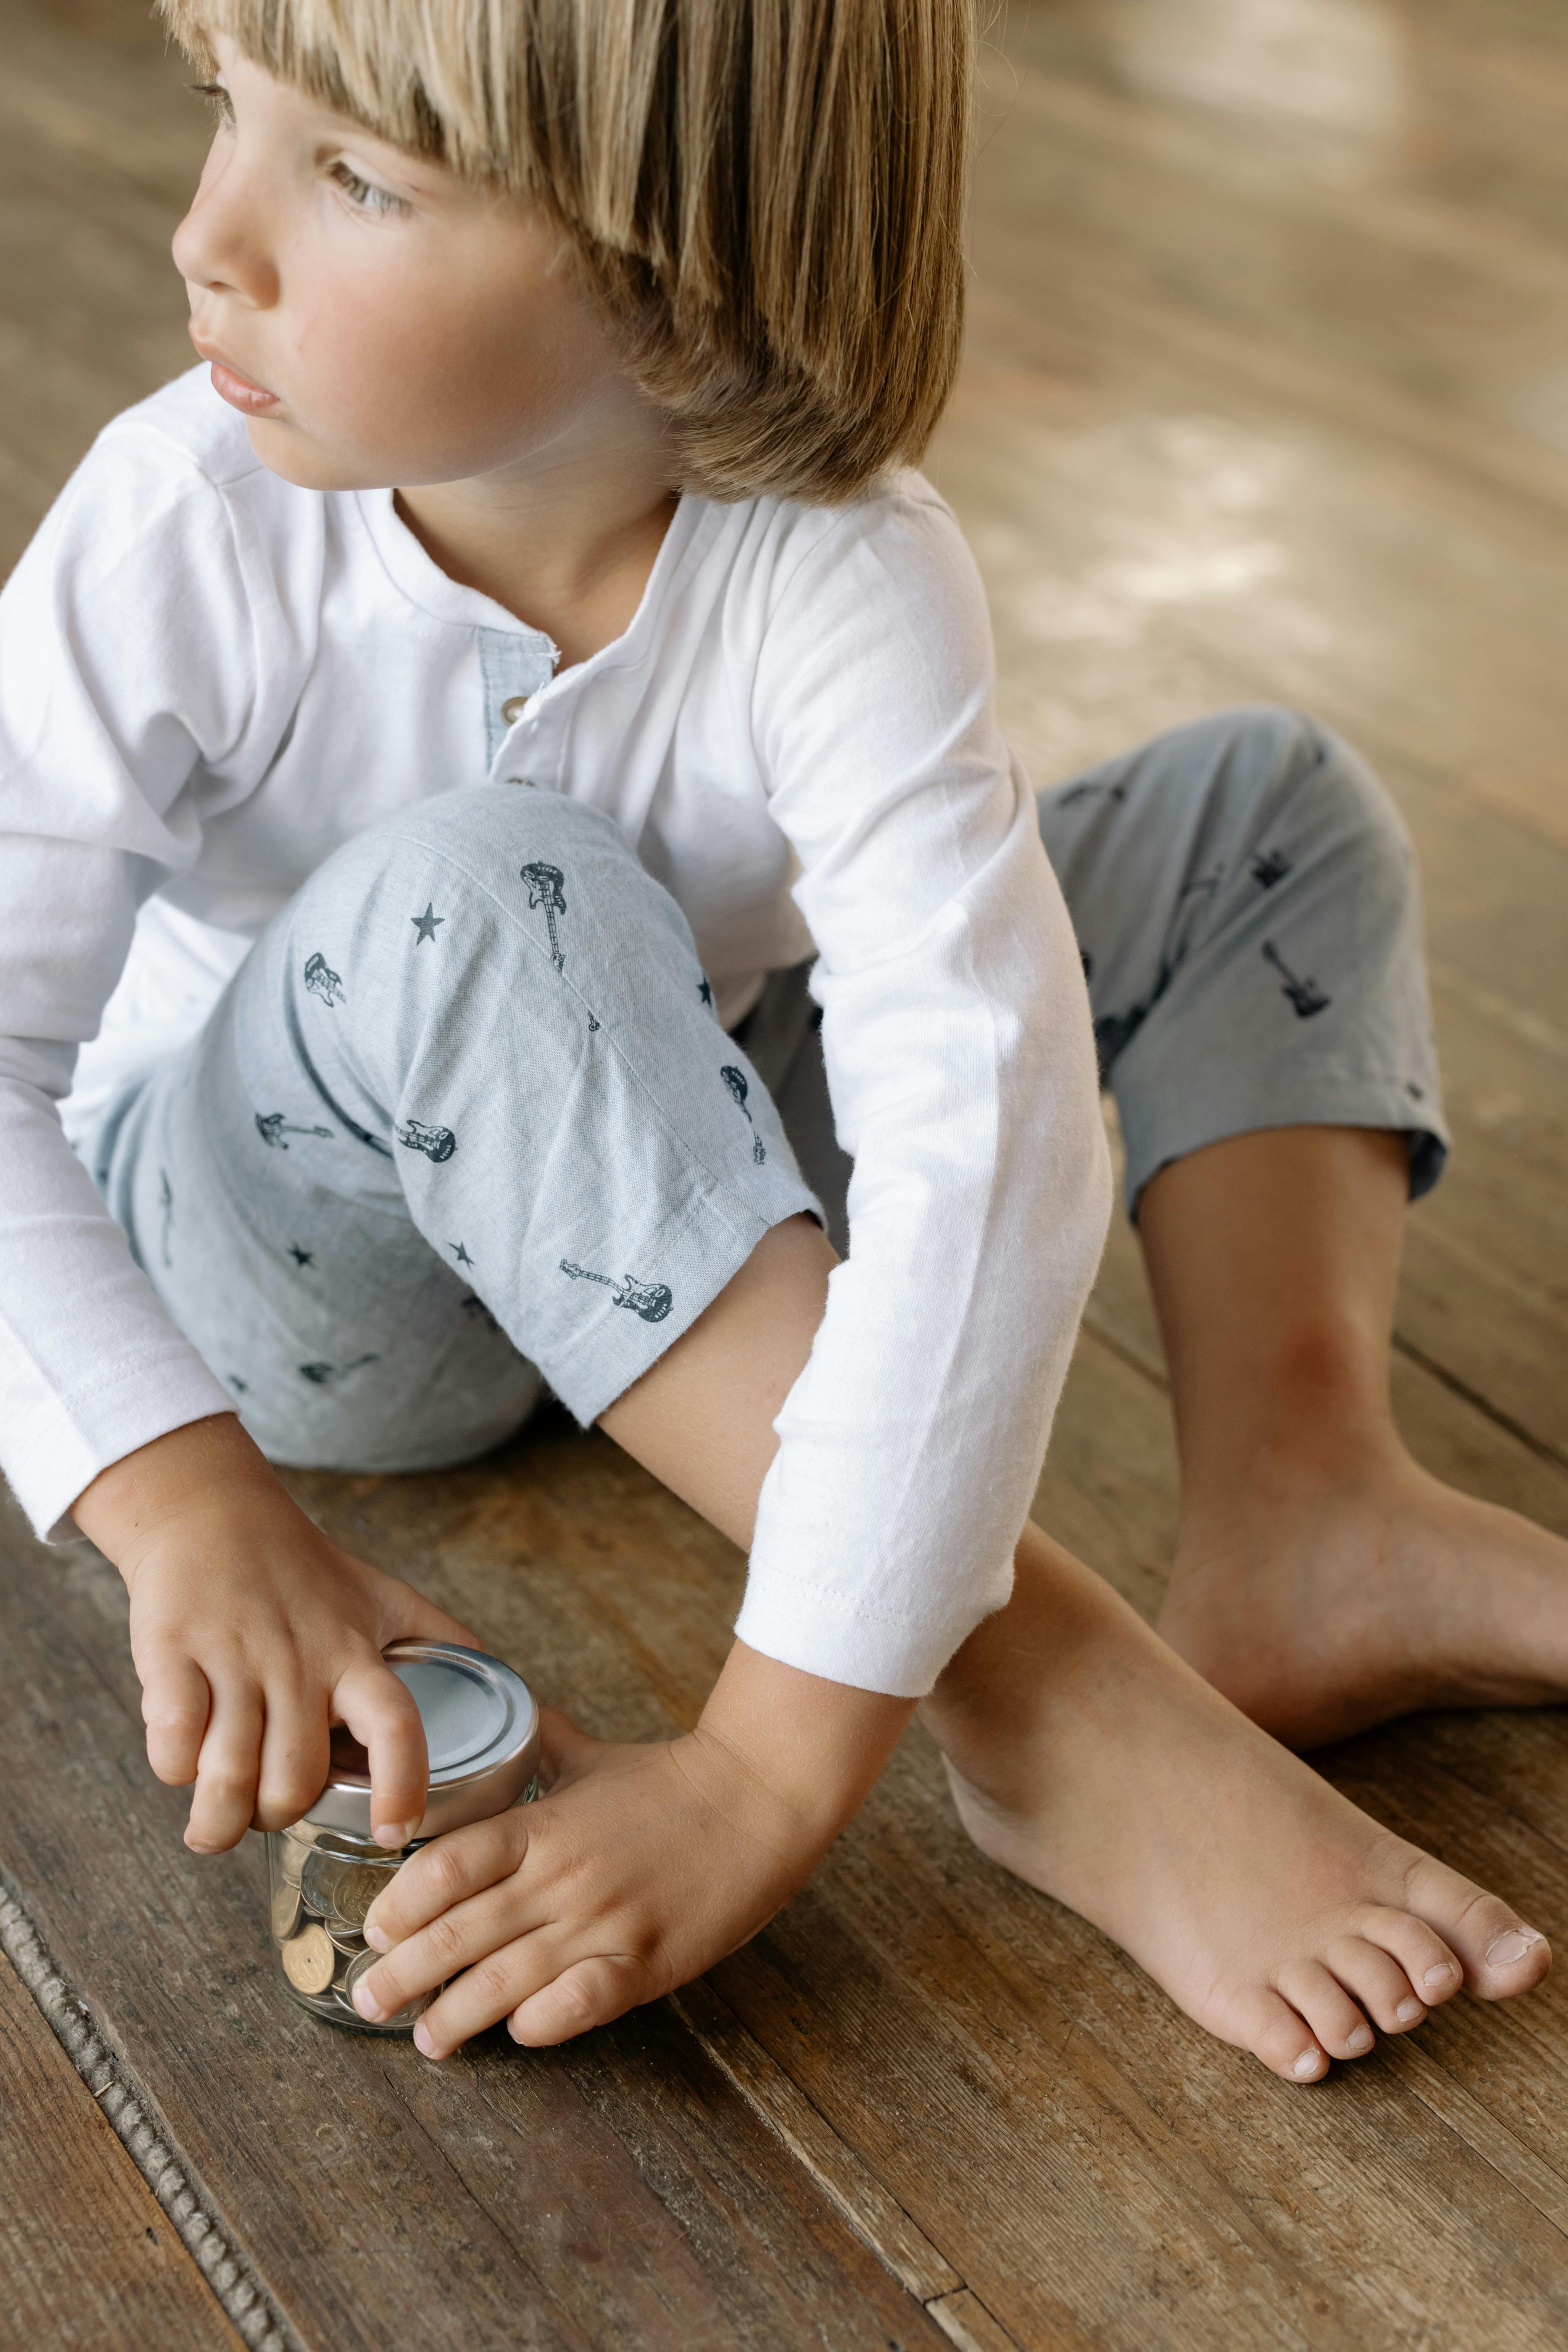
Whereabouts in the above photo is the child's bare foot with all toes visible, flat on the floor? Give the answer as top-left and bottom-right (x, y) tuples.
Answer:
(922, 1529), (1551, 2082)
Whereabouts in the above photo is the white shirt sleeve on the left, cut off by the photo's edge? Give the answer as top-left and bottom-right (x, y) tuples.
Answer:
(0, 428), (276, 1538)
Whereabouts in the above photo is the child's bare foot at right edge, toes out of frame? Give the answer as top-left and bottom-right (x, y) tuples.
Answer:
(1159, 1451), (1568, 1748)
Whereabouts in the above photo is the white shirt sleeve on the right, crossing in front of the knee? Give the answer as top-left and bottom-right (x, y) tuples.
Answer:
(736, 482), (1109, 1698)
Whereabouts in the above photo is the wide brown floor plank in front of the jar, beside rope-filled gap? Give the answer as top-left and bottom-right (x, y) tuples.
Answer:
(0, 1486), (945, 2352)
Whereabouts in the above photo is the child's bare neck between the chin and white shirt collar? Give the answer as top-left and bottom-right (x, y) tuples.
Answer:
(397, 388), (677, 668)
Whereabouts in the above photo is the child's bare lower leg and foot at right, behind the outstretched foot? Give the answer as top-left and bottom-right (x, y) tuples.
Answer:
(1138, 1127), (1568, 1748)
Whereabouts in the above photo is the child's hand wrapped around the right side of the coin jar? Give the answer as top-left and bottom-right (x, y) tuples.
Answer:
(355, 1642), (912, 2058)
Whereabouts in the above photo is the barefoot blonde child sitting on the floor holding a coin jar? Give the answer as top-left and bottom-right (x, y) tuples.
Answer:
(0, 0), (1561, 2082)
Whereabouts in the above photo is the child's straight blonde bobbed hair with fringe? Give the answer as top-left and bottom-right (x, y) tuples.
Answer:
(160, 0), (976, 503)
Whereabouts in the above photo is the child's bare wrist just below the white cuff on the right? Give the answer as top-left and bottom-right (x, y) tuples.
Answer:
(694, 1642), (915, 1851)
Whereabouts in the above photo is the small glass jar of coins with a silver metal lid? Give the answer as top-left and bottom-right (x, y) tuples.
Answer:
(266, 1642), (538, 2034)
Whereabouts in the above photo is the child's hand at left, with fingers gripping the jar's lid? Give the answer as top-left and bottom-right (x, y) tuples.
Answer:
(73, 1413), (482, 1853)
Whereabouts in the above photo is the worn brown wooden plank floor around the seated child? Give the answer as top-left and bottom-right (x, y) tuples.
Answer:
(0, 0), (1568, 2352)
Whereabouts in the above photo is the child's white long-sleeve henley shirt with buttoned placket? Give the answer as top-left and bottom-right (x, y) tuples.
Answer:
(0, 369), (1109, 1696)
